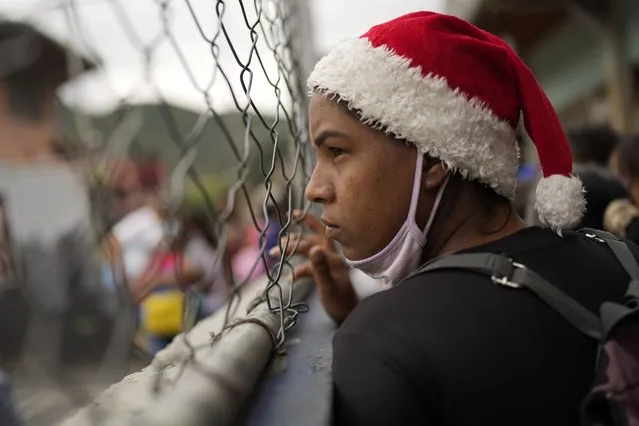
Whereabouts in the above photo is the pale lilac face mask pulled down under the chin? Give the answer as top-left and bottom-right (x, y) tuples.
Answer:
(346, 152), (449, 289)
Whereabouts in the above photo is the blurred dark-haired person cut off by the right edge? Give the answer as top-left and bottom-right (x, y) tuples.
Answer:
(604, 134), (639, 243)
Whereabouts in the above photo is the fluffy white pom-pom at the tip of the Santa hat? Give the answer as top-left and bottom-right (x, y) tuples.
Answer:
(535, 175), (586, 235)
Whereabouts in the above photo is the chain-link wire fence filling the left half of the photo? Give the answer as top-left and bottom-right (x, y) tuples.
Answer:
(0, 0), (312, 425)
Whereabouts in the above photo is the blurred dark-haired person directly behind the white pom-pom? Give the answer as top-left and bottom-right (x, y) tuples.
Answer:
(528, 125), (628, 229)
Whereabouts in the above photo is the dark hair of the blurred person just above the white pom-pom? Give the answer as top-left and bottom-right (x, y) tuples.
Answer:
(568, 125), (619, 166)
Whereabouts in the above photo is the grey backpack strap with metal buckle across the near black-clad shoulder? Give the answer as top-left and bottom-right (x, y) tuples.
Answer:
(416, 253), (602, 339)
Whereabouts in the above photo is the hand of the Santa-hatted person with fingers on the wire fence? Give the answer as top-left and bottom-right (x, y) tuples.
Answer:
(269, 211), (357, 324)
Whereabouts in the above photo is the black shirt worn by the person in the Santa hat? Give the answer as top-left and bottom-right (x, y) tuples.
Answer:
(333, 227), (639, 426)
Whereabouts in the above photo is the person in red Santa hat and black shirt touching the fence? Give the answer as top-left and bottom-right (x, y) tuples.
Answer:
(272, 12), (628, 426)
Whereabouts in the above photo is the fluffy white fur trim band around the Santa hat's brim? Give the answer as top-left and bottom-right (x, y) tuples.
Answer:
(308, 38), (519, 199)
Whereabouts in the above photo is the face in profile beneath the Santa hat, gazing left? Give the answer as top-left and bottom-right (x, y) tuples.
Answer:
(306, 94), (417, 260)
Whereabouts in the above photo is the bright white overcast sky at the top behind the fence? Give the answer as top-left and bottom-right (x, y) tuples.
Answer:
(0, 0), (445, 113)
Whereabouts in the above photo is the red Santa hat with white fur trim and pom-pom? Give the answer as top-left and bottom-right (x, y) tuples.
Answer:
(308, 12), (585, 232)
